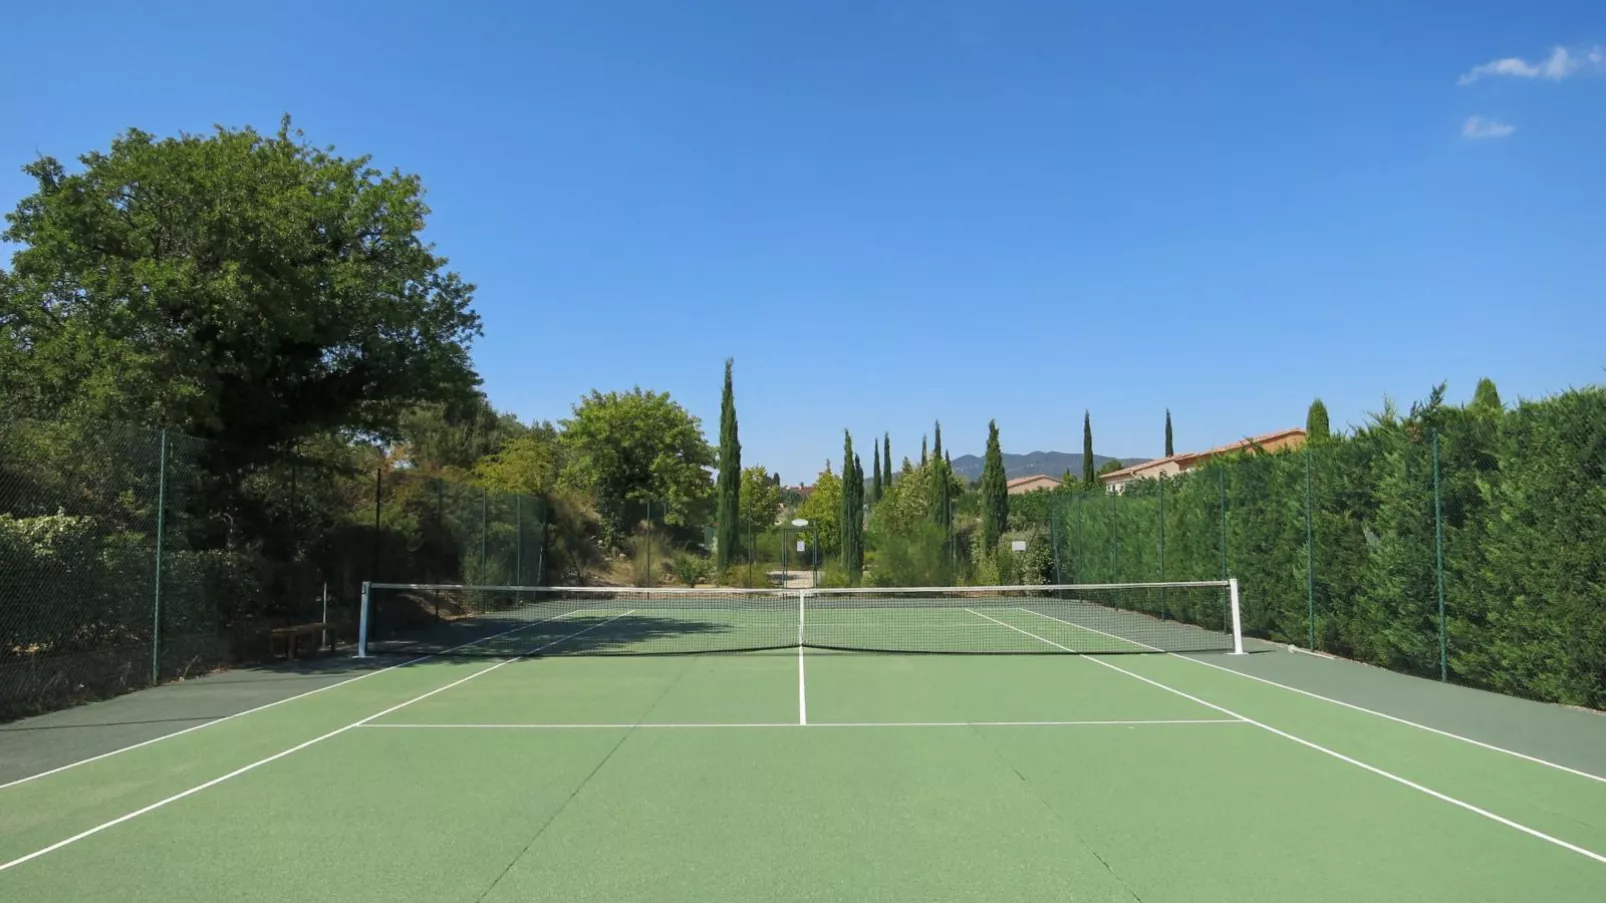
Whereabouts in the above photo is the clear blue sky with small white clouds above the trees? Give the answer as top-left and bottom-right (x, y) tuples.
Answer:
(0, 0), (1606, 482)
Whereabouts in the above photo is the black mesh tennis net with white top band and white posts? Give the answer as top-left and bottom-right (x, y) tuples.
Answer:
(358, 580), (1243, 657)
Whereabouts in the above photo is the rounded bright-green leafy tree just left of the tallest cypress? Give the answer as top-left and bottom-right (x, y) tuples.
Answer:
(562, 387), (715, 541)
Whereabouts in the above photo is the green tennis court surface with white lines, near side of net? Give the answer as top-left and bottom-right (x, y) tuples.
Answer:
(0, 609), (1606, 903)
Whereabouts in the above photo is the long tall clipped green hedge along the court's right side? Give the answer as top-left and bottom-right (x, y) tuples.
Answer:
(1054, 379), (1606, 709)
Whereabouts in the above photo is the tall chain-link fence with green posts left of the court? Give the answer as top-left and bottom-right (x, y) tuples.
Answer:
(0, 421), (548, 720)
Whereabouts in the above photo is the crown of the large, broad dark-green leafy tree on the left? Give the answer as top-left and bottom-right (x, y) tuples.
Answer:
(0, 119), (480, 462)
